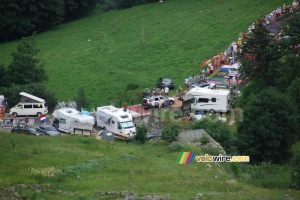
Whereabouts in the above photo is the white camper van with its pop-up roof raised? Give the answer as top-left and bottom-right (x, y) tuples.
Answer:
(9, 92), (48, 117)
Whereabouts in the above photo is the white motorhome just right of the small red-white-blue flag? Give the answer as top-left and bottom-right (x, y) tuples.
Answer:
(52, 108), (95, 135)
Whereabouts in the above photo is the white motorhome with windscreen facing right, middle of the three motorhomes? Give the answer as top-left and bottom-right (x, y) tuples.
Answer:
(96, 106), (136, 137)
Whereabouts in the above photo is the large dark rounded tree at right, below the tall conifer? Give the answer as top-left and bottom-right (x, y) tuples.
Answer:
(237, 88), (298, 163)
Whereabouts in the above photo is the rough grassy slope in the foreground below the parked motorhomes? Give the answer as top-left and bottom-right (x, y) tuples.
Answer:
(0, 133), (300, 200)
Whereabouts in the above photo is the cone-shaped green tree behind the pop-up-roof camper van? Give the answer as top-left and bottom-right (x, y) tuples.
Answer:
(7, 36), (48, 85)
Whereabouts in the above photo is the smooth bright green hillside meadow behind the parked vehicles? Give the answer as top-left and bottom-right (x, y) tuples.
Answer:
(0, 0), (291, 106)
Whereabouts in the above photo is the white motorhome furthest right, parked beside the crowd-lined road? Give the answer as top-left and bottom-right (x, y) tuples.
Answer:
(187, 88), (230, 113)
